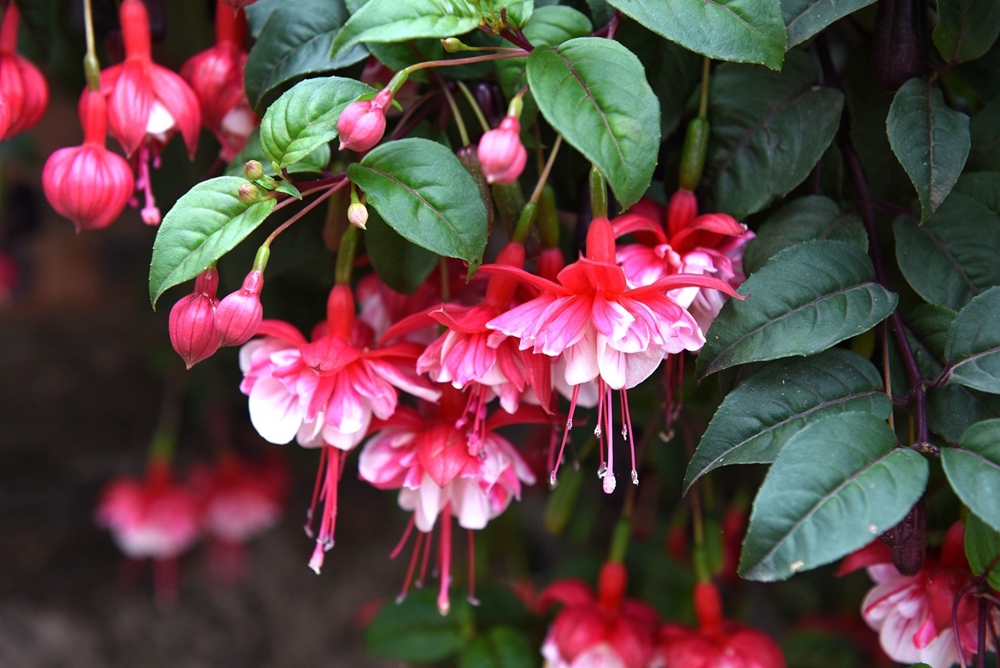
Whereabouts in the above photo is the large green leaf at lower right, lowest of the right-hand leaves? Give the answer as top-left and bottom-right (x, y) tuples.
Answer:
(739, 413), (924, 582)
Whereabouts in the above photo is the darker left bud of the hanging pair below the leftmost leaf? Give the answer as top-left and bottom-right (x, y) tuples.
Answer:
(170, 268), (219, 369)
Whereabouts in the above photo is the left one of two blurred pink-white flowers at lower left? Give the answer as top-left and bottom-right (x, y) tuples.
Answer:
(95, 460), (201, 602)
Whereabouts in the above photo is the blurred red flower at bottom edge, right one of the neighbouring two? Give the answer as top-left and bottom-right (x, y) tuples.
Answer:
(653, 582), (787, 668)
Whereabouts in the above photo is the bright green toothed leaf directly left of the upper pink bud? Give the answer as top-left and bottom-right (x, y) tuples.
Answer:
(260, 77), (375, 168)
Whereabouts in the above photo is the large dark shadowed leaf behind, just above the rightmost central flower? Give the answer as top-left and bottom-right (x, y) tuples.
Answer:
(703, 51), (844, 219)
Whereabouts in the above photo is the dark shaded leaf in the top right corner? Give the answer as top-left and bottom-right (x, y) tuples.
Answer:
(933, 0), (1000, 63)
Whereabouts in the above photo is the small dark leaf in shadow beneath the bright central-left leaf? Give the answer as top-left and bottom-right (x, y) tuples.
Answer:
(365, 210), (439, 295)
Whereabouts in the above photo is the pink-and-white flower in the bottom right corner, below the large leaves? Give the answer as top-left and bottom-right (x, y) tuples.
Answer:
(839, 523), (1000, 668)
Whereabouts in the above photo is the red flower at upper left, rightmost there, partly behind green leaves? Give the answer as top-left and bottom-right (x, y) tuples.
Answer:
(181, 0), (259, 162)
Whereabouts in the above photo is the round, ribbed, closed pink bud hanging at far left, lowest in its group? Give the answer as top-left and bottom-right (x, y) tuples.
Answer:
(42, 90), (134, 232)
